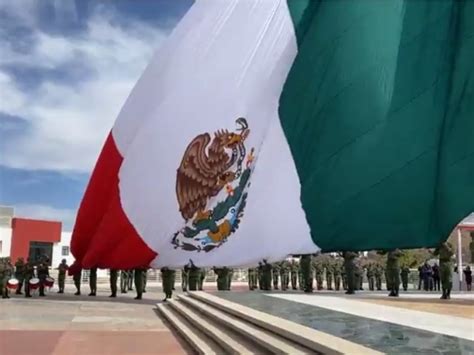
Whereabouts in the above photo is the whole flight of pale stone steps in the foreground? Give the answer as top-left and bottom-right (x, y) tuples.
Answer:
(157, 292), (379, 355)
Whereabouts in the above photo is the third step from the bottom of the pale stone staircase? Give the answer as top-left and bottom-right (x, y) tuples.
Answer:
(178, 295), (308, 355)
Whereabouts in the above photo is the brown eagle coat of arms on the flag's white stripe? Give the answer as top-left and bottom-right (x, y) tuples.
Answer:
(172, 117), (255, 252)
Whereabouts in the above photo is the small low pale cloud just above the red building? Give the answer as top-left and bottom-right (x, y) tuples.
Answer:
(15, 204), (76, 231)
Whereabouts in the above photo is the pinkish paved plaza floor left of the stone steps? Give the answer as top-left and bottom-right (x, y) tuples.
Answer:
(0, 285), (190, 355)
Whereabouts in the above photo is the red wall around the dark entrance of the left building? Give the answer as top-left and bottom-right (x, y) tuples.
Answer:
(10, 218), (61, 262)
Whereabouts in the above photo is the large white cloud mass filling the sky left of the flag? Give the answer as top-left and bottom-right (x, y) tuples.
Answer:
(0, 4), (165, 172)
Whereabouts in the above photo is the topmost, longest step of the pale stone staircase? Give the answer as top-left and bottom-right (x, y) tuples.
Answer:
(187, 292), (381, 355)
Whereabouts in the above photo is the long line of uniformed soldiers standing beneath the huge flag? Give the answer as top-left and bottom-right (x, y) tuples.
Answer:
(0, 243), (472, 301)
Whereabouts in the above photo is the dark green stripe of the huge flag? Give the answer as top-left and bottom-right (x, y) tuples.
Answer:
(279, 0), (474, 251)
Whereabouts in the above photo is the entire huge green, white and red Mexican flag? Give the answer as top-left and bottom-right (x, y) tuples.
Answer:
(72, 0), (474, 268)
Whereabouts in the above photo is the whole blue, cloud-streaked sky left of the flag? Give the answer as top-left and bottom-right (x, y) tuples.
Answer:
(0, 0), (192, 230)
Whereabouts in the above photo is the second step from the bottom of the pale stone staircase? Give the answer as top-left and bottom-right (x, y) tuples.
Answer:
(168, 297), (263, 354)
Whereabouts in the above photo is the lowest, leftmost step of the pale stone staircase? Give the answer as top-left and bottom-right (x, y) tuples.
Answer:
(156, 303), (222, 355)
